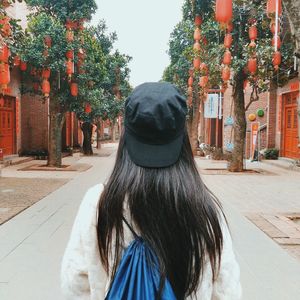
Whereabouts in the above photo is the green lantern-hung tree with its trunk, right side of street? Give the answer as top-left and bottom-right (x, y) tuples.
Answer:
(163, 0), (293, 170)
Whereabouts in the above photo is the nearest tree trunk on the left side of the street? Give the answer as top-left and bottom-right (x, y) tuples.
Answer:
(47, 99), (65, 168)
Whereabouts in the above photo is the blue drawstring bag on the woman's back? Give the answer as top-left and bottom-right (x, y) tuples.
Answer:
(105, 220), (176, 300)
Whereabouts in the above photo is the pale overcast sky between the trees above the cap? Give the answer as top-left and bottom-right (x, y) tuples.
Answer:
(92, 0), (183, 87)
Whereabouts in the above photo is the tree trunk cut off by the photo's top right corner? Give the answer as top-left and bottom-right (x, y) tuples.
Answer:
(283, 0), (300, 148)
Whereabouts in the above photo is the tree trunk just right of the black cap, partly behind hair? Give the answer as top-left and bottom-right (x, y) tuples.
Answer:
(190, 85), (201, 155)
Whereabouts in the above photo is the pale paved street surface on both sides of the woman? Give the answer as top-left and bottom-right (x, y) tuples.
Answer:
(0, 145), (300, 300)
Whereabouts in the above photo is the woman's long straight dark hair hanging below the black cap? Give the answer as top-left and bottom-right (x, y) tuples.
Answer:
(97, 133), (223, 300)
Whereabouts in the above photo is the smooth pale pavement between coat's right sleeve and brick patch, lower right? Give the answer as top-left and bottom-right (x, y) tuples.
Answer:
(222, 201), (300, 300)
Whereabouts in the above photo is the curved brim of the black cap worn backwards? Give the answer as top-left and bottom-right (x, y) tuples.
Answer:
(125, 130), (184, 168)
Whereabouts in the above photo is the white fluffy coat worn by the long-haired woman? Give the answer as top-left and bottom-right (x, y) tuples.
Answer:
(61, 184), (241, 300)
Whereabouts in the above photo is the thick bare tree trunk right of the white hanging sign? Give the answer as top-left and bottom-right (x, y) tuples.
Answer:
(228, 70), (247, 172)
